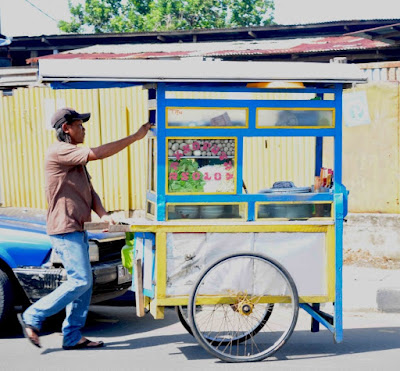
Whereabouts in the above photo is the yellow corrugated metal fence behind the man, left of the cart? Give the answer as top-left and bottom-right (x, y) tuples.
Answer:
(0, 87), (147, 210)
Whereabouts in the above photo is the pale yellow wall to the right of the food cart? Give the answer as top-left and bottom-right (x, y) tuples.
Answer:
(343, 81), (400, 214)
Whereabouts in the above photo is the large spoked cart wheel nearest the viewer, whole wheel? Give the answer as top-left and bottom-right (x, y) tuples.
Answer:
(188, 253), (299, 362)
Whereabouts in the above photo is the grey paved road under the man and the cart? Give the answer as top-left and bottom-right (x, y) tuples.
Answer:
(0, 306), (400, 371)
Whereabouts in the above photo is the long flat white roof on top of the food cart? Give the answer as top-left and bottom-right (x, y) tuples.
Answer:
(39, 59), (367, 83)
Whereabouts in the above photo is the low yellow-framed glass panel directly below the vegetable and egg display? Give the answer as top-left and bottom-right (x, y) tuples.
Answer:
(167, 204), (246, 220)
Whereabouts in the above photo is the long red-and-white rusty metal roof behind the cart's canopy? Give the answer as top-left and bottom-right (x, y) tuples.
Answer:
(32, 36), (390, 63)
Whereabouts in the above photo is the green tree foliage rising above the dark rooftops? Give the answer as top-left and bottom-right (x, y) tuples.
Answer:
(58, 0), (274, 33)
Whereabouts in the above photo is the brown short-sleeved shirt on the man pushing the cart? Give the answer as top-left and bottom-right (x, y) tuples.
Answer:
(45, 142), (92, 235)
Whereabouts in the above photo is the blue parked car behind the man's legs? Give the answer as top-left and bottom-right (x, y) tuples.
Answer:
(0, 208), (132, 329)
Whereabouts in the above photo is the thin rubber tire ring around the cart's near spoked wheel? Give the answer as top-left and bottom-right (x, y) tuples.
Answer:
(188, 252), (299, 363)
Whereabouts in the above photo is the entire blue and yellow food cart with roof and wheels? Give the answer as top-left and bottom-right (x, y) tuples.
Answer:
(39, 60), (365, 362)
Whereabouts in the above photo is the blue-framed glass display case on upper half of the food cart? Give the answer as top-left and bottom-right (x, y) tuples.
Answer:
(146, 83), (341, 221)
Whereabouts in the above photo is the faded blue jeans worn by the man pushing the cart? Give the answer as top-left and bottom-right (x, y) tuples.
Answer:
(23, 232), (93, 346)
